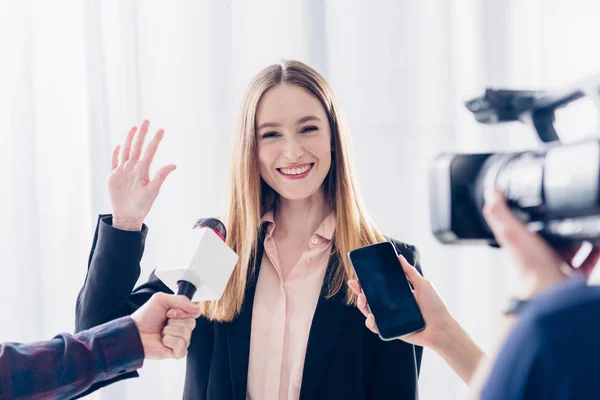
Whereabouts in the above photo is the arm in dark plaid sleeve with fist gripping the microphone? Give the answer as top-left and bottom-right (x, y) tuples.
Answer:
(0, 294), (198, 400)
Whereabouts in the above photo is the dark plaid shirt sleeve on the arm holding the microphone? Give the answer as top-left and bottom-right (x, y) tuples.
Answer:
(0, 317), (144, 400)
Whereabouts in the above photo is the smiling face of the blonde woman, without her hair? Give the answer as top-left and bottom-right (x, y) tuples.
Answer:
(256, 84), (331, 200)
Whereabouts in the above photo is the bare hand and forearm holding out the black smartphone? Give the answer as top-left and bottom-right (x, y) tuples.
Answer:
(348, 256), (484, 383)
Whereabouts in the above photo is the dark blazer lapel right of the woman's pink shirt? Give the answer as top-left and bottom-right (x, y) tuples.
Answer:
(300, 255), (346, 400)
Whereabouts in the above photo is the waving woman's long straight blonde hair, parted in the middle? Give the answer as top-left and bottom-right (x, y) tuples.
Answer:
(202, 60), (385, 321)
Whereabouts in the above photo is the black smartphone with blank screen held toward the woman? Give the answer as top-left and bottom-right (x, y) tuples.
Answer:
(348, 242), (425, 340)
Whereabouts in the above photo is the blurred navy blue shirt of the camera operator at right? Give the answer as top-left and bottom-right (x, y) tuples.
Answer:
(481, 275), (600, 400)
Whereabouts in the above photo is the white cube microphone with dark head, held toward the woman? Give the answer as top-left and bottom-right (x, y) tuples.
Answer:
(155, 218), (239, 301)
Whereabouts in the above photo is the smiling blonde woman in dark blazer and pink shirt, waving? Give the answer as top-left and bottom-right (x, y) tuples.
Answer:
(77, 61), (422, 399)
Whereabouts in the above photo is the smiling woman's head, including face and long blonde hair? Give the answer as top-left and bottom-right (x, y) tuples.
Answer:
(216, 60), (386, 321)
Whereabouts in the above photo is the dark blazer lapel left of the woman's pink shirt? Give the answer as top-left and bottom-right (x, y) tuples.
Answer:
(227, 230), (264, 400)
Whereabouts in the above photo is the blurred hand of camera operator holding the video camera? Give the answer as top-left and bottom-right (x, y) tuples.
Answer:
(483, 190), (600, 299)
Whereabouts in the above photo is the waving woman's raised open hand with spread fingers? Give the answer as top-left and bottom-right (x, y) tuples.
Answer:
(108, 121), (175, 231)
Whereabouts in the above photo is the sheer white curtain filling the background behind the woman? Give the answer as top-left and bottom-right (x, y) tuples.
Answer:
(0, 0), (600, 400)
